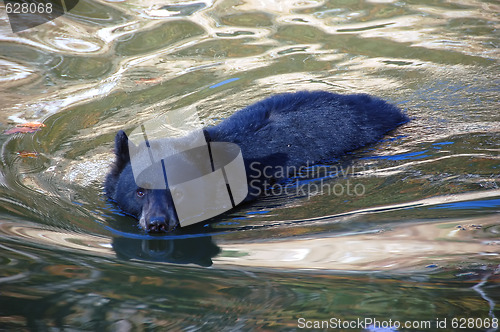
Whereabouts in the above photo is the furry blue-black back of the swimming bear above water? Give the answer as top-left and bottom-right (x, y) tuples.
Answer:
(206, 91), (408, 167)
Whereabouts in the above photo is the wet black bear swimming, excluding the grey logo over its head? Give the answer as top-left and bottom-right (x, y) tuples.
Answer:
(105, 91), (408, 232)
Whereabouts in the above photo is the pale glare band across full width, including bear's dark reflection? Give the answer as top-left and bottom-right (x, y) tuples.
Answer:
(0, 210), (500, 273)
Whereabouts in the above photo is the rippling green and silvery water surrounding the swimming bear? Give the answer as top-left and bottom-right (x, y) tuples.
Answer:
(0, 0), (500, 331)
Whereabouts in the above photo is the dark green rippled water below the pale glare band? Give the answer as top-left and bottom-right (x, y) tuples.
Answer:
(0, 228), (499, 330)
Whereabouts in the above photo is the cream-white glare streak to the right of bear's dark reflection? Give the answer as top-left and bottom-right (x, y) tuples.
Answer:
(214, 217), (500, 272)
